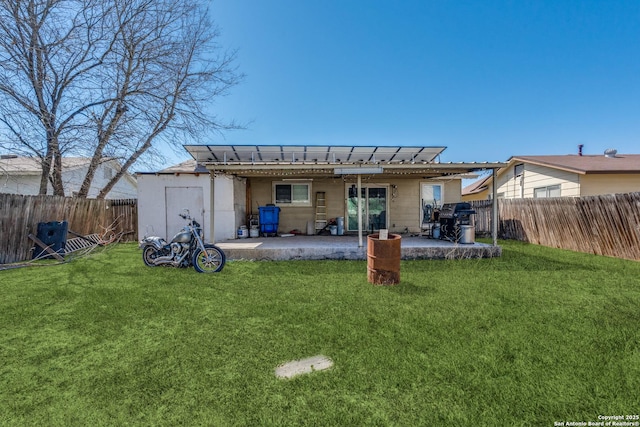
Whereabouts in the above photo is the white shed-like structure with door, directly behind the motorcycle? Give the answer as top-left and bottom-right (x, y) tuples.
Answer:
(136, 160), (246, 243)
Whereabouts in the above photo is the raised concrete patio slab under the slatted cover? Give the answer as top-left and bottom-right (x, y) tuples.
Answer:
(216, 235), (502, 261)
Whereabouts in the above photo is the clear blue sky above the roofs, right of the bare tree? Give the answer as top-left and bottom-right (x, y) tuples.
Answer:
(180, 0), (640, 162)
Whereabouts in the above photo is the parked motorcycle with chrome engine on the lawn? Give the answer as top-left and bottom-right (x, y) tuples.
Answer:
(139, 209), (226, 273)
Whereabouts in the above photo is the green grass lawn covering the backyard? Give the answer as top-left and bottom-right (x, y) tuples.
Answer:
(0, 242), (640, 426)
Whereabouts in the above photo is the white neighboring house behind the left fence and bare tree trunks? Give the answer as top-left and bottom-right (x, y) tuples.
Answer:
(0, 155), (137, 199)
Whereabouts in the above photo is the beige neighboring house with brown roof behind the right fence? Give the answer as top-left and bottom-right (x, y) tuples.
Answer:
(463, 150), (640, 200)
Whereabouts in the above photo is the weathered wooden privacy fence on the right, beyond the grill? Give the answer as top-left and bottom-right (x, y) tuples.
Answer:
(472, 193), (640, 260)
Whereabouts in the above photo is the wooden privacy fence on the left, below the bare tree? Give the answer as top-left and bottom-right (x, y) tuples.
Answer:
(0, 194), (138, 264)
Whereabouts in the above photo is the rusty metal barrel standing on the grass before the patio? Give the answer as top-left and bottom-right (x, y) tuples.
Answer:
(367, 234), (402, 285)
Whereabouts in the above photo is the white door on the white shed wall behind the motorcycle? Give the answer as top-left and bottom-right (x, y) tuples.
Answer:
(164, 187), (205, 241)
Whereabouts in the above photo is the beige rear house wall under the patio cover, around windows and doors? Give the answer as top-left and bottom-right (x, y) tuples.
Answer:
(248, 177), (461, 233)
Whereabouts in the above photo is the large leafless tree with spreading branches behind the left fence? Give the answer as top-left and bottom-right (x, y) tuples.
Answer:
(0, 0), (242, 198)
